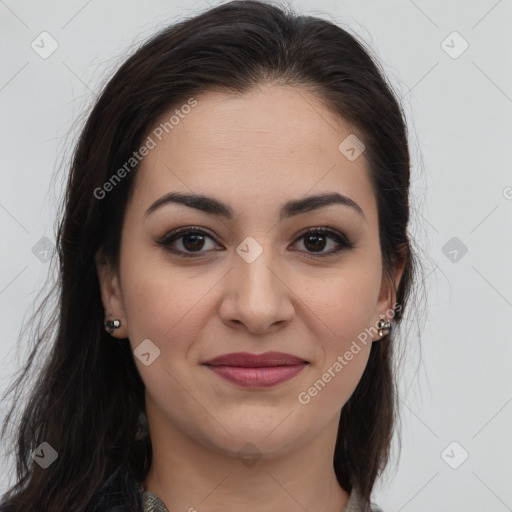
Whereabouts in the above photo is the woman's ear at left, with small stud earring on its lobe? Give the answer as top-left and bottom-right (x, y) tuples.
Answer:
(94, 248), (128, 338)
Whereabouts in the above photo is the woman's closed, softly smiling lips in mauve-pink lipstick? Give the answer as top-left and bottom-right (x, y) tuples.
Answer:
(203, 352), (309, 388)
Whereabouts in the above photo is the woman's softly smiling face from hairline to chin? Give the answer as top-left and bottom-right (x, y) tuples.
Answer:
(98, 85), (400, 456)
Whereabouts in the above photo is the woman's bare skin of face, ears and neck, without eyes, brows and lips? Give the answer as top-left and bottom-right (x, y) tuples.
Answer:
(98, 85), (402, 512)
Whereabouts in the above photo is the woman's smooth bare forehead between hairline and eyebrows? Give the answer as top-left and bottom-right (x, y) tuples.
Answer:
(130, 85), (375, 224)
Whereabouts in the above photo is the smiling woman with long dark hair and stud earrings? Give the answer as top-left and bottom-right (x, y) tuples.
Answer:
(2, 1), (424, 512)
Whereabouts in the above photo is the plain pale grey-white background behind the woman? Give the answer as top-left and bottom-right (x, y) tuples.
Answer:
(0, 0), (512, 512)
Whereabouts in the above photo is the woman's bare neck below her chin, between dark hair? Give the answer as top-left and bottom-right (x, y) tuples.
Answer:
(143, 404), (349, 512)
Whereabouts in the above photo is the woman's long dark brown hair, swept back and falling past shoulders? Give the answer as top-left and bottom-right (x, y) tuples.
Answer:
(2, 0), (424, 512)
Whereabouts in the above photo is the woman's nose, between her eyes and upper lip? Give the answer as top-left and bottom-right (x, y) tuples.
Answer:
(219, 249), (295, 334)
